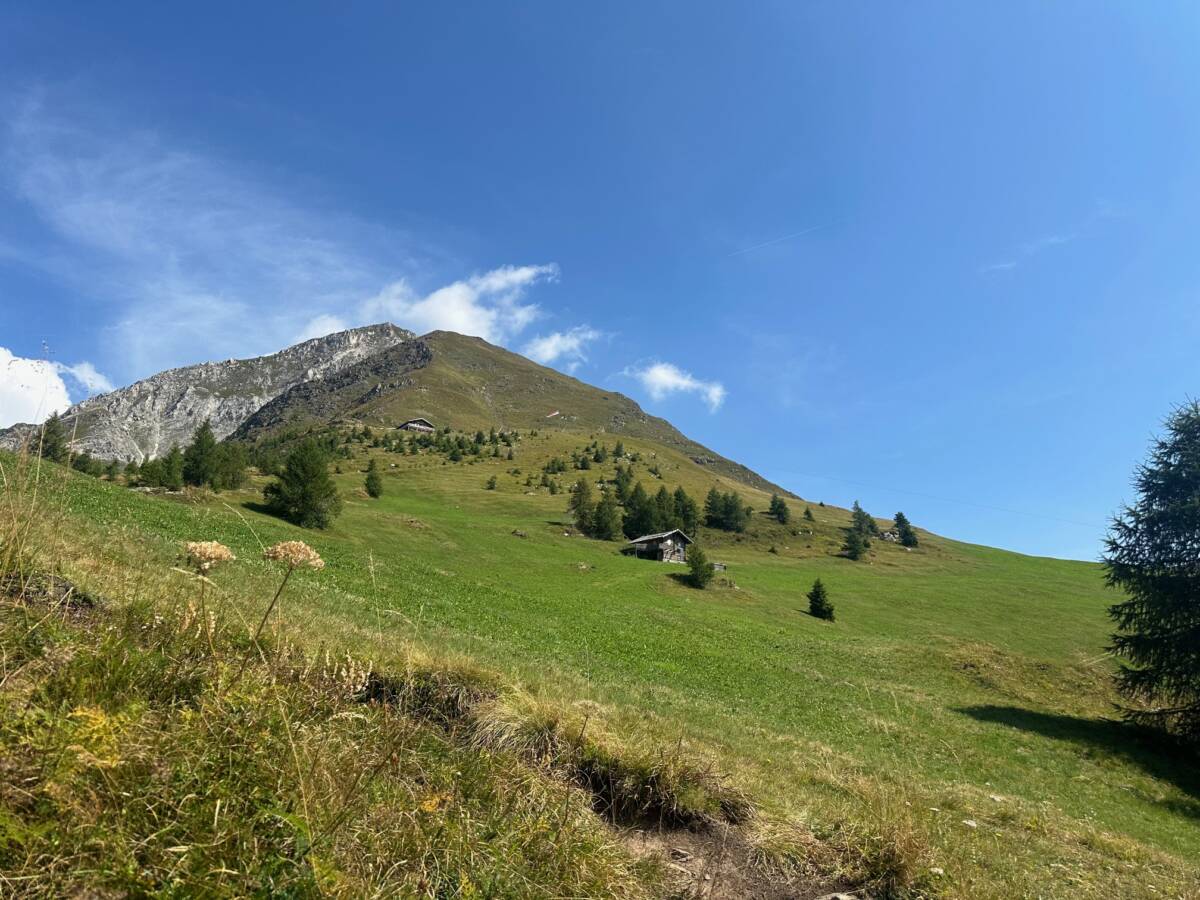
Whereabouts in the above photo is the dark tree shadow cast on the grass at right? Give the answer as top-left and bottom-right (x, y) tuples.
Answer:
(956, 704), (1200, 818)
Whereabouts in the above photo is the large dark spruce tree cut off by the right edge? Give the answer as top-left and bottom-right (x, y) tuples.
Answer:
(1104, 401), (1200, 744)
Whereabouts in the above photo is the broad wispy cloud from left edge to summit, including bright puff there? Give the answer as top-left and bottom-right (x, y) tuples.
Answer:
(0, 96), (571, 381)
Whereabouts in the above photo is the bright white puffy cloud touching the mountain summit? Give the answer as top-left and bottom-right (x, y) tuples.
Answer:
(361, 263), (558, 343)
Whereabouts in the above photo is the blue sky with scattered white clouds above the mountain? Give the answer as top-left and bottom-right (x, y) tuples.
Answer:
(0, 2), (1200, 558)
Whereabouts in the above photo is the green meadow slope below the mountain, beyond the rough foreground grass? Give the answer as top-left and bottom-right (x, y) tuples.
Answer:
(11, 432), (1200, 898)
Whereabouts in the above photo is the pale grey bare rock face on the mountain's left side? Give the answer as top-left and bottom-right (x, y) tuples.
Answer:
(0, 323), (414, 462)
